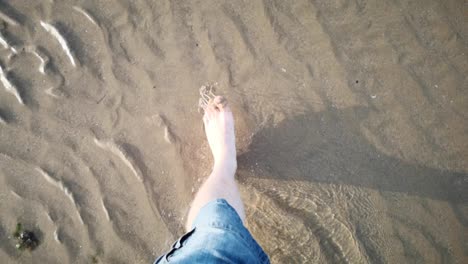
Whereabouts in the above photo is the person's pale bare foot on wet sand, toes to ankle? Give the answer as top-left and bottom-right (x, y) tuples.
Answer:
(203, 96), (237, 173)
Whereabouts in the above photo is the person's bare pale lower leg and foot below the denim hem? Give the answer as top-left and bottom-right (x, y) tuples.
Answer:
(185, 96), (245, 231)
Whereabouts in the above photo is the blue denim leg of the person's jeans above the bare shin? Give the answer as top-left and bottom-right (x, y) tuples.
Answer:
(154, 199), (270, 264)
